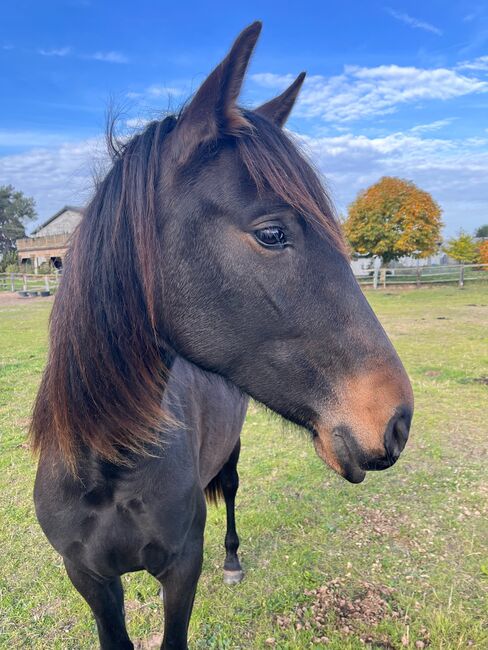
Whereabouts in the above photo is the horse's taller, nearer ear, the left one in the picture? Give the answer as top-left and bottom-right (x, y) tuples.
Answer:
(174, 21), (262, 162)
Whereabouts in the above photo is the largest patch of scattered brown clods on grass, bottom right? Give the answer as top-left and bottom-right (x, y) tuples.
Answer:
(276, 578), (429, 650)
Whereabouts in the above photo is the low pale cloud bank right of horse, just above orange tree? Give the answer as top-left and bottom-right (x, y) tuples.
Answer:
(300, 132), (488, 234)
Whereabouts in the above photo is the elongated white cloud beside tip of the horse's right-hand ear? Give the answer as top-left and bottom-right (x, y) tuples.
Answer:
(252, 65), (488, 123)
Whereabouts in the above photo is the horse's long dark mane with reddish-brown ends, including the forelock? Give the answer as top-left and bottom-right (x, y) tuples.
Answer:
(30, 111), (345, 473)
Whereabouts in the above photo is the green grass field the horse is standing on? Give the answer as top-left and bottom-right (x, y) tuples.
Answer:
(0, 283), (488, 650)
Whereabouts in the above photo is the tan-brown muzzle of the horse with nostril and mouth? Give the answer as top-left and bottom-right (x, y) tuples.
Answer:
(314, 363), (413, 483)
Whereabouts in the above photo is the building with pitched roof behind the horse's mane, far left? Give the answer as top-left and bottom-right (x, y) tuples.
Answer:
(17, 205), (83, 273)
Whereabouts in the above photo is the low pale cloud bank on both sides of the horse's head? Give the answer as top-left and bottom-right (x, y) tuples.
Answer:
(0, 125), (488, 234)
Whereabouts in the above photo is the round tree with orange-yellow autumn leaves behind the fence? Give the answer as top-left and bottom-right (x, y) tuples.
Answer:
(344, 176), (442, 264)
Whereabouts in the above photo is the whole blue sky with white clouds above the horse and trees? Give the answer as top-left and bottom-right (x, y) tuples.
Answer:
(0, 0), (488, 236)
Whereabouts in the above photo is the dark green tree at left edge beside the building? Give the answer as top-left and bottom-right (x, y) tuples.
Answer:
(0, 185), (37, 257)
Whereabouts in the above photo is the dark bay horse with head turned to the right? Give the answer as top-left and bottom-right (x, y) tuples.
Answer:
(31, 23), (413, 650)
